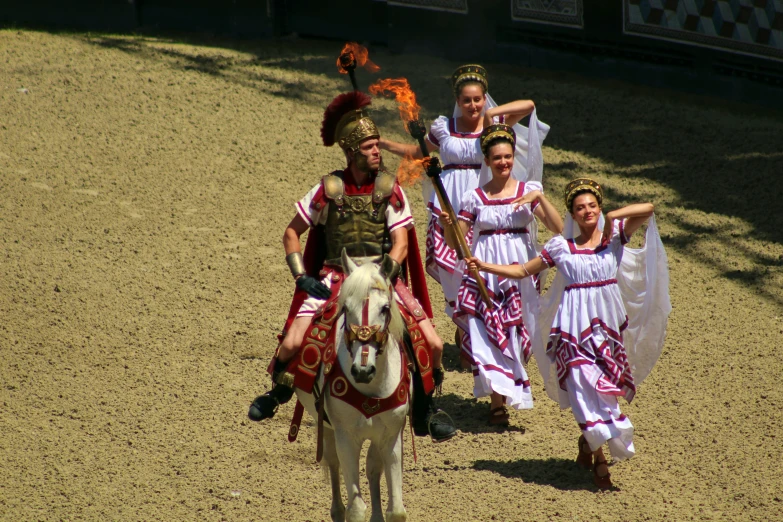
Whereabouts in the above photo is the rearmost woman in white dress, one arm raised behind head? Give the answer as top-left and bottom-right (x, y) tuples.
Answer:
(380, 65), (549, 328)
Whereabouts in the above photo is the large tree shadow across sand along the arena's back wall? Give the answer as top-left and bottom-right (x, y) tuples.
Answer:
(64, 28), (783, 306)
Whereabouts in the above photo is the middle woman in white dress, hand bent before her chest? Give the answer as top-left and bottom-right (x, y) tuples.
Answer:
(440, 123), (563, 425)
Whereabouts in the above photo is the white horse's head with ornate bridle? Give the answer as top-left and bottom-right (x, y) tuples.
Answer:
(340, 250), (404, 384)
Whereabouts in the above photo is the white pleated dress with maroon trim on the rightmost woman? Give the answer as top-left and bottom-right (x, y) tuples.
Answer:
(541, 220), (636, 460)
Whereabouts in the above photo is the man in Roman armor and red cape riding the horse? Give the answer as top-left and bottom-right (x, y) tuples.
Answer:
(248, 91), (456, 441)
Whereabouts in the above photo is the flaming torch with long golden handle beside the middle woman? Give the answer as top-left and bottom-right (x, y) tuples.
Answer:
(370, 78), (495, 310)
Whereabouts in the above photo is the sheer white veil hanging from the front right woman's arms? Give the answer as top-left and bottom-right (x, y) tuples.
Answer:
(533, 214), (672, 408)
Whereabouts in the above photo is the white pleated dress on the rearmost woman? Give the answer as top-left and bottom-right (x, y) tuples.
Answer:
(425, 116), (484, 317)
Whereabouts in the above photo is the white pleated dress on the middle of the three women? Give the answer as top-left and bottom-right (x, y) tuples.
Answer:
(454, 181), (543, 409)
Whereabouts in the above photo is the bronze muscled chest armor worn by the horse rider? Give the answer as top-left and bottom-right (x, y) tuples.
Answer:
(323, 173), (395, 265)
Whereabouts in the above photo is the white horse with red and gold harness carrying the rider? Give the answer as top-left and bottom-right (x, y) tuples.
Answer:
(296, 251), (413, 522)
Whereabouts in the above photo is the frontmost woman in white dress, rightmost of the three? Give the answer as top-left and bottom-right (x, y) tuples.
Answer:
(468, 178), (671, 488)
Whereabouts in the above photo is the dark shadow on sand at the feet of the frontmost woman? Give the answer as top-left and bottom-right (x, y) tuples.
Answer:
(473, 458), (598, 491)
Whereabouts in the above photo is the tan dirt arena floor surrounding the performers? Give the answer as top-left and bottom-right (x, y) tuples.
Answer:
(0, 29), (783, 522)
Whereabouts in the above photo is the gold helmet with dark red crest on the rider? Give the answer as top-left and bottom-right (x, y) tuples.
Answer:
(321, 91), (381, 152)
